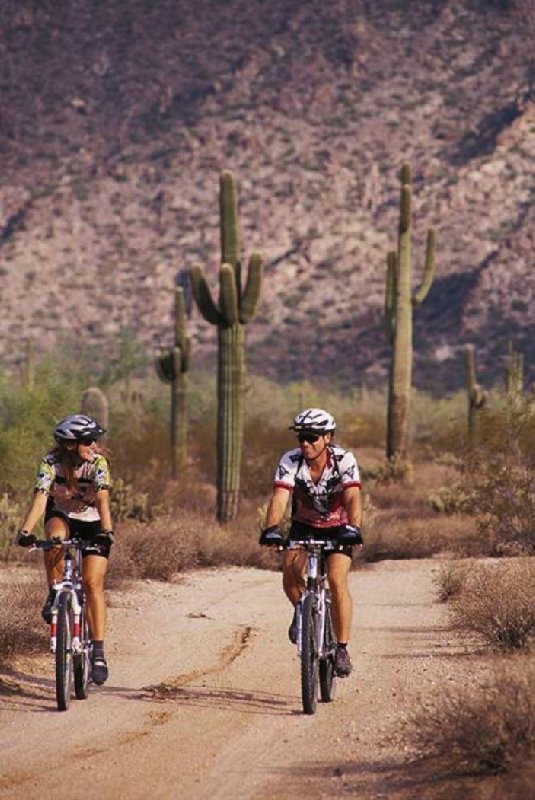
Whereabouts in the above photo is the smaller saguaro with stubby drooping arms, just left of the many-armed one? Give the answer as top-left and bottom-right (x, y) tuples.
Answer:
(156, 286), (191, 478)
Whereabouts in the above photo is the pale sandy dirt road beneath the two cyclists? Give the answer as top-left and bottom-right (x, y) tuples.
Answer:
(0, 561), (463, 800)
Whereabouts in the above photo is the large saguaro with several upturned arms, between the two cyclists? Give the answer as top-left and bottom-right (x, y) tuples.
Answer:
(190, 171), (263, 523)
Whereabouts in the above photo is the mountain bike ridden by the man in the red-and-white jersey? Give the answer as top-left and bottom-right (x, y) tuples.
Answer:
(286, 539), (339, 714)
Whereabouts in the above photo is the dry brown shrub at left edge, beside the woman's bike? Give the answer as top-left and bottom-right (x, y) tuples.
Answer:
(0, 576), (47, 664)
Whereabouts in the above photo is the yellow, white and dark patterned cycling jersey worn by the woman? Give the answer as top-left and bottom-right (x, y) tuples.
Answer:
(34, 450), (110, 522)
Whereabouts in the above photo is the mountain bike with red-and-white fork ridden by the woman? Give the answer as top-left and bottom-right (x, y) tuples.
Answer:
(34, 538), (92, 711)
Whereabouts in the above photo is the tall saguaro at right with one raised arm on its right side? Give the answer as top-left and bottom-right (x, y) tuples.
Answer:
(385, 164), (436, 458)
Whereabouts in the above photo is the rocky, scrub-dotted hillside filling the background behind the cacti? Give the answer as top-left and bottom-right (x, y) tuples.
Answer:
(0, 0), (535, 391)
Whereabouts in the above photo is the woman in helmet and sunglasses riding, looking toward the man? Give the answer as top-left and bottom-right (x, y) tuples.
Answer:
(17, 414), (113, 685)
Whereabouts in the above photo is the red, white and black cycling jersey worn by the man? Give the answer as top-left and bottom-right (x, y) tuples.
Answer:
(275, 445), (360, 528)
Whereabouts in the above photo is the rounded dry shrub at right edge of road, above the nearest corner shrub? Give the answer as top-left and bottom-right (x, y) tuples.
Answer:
(451, 558), (535, 649)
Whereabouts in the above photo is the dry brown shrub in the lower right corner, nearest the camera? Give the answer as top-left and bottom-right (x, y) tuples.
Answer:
(402, 669), (535, 774)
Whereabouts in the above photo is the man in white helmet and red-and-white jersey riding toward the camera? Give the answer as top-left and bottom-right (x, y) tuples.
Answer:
(260, 408), (362, 677)
